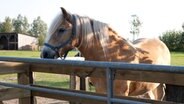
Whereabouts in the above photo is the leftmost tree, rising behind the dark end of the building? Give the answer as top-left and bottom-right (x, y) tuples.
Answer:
(0, 17), (13, 32)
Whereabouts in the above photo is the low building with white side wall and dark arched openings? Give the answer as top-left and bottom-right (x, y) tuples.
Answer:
(0, 33), (38, 50)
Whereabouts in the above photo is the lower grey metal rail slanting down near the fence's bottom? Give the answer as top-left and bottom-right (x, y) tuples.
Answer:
(0, 82), (146, 104)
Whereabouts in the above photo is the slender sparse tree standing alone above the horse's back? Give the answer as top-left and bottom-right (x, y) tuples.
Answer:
(130, 15), (142, 41)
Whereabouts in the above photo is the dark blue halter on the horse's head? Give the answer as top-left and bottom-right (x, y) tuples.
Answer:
(44, 15), (76, 59)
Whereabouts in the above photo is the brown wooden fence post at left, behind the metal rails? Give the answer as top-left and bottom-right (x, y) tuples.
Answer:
(18, 65), (34, 104)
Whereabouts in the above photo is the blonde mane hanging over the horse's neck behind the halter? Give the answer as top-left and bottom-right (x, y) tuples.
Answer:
(76, 16), (109, 57)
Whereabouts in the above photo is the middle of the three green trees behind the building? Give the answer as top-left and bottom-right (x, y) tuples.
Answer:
(13, 14), (29, 34)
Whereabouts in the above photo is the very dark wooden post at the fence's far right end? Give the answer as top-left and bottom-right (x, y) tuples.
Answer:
(166, 84), (184, 103)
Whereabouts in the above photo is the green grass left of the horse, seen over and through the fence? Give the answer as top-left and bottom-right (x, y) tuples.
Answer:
(0, 50), (77, 88)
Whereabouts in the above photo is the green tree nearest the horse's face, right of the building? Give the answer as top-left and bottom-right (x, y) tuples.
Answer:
(29, 16), (47, 46)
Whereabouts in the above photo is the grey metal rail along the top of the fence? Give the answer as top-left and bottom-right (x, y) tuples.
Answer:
(0, 57), (184, 74)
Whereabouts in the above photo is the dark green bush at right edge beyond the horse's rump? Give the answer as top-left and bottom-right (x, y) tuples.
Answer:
(159, 31), (184, 51)
